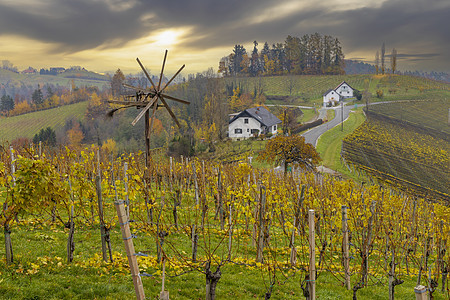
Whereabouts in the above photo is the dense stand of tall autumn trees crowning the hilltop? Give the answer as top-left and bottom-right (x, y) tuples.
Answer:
(219, 33), (345, 77)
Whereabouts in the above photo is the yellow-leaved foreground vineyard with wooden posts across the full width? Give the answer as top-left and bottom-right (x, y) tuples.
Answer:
(0, 146), (450, 299)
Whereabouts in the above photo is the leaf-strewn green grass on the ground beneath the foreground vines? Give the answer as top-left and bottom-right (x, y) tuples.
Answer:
(0, 219), (445, 300)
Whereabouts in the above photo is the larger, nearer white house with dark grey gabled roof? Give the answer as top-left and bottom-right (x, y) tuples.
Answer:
(228, 106), (281, 140)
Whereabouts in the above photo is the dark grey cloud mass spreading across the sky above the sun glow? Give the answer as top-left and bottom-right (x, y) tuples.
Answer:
(0, 0), (450, 69)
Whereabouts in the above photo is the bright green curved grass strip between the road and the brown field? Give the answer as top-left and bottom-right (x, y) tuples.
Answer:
(317, 108), (365, 179)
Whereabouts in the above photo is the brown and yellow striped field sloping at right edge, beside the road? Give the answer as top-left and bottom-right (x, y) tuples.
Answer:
(343, 101), (450, 202)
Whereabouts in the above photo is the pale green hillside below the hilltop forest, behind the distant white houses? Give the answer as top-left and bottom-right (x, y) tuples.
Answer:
(224, 74), (450, 105)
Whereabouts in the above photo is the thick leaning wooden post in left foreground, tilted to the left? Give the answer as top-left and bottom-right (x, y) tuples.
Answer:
(114, 201), (145, 300)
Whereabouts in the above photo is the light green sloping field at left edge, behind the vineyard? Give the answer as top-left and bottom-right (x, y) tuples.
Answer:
(0, 102), (88, 141)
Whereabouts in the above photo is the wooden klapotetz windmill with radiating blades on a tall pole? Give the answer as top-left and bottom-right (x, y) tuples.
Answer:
(108, 50), (190, 168)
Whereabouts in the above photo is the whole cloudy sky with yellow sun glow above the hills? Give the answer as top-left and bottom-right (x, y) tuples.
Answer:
(0, 0), (450, 75)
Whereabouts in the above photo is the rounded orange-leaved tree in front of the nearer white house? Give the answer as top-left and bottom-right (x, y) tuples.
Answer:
(257, 135), (321, 173)
